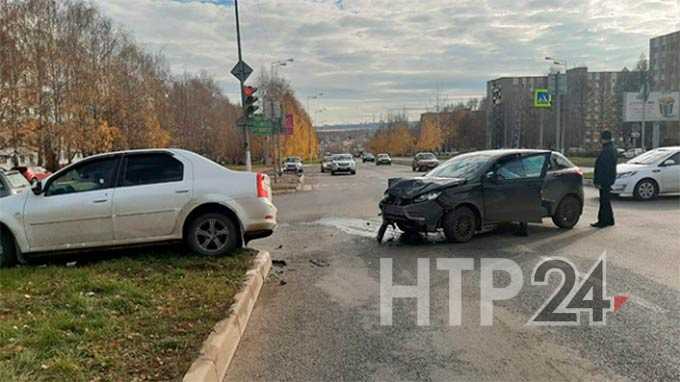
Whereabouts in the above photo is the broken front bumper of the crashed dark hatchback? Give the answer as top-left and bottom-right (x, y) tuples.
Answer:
(380, 201), (444, 231)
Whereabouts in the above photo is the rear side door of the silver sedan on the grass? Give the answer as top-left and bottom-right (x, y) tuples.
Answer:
(113, 152), (193, 241)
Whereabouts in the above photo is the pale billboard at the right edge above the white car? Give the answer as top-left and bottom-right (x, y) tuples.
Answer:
(623, 92), (680, 122)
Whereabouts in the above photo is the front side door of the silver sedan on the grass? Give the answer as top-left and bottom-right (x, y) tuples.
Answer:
(24, 156), (119, 251)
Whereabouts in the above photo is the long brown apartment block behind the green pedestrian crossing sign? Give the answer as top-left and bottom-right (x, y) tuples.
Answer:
(487, 67), (641, 151)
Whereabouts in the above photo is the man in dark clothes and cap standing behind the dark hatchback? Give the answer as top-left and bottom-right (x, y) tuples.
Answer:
(591, 130), (617, 228)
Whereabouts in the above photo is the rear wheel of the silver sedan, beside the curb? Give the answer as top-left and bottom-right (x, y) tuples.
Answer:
(185, 213), (240, 256)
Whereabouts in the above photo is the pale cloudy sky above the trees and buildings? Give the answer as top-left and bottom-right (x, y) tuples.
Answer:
(92, 0), (680, 123)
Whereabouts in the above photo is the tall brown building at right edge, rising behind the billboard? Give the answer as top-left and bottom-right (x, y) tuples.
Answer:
(649, 31), (680, 91)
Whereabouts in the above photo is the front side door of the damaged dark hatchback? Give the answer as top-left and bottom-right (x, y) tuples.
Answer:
(483, 153), (550, 223)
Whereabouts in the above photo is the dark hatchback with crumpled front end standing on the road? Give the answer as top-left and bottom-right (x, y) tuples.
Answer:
(378, 149), (583, 242)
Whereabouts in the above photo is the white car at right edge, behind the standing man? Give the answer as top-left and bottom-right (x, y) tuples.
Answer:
(612, 146), (680, 200)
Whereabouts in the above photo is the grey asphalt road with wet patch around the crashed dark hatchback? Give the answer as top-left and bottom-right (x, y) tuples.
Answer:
(226, 165), (680, 381)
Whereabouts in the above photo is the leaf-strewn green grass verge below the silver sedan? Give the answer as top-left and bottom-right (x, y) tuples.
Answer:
(0, 248), (252, 381)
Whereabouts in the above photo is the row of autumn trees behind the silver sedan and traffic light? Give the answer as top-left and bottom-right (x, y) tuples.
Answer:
(0, 0), (306, 170)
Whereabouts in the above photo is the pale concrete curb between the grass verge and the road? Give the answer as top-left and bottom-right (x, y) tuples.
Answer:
(182, 251), (272, 382)
